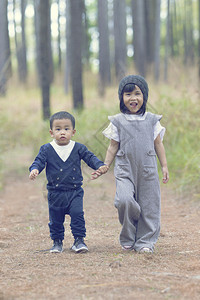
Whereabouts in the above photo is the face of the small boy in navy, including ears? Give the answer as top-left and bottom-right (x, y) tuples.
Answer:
(49, 119), (76, 146)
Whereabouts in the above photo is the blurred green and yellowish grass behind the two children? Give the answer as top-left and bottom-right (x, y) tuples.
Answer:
(0, 74), (200, 199)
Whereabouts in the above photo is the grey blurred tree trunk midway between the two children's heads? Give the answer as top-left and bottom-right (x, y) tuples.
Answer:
(98, 0), (111, 96)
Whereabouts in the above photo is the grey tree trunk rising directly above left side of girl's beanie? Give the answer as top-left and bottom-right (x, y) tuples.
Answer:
(113, 0), (127, 80)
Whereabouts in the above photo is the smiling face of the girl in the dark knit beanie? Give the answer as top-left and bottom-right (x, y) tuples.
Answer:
(123, 85), (144, 114)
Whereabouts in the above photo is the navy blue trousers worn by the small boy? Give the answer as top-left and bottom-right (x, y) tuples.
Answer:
(48, 188), (86, 240)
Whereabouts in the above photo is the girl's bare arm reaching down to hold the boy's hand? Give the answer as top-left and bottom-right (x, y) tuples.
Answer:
(92, 140), (119, 179)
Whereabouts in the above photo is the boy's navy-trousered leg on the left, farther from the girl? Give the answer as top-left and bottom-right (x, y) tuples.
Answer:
(48, 191), (65, 240)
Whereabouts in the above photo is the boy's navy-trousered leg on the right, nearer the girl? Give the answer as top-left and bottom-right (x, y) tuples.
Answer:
(69, 188), (86, 238)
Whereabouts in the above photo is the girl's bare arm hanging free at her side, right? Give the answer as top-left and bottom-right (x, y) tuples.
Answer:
(154, 135), (169, 183)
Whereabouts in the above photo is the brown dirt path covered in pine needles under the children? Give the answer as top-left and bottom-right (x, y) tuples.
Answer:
(0, 173), (200, 300)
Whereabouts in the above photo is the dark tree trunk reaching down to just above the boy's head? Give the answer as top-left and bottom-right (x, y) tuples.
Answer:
(34, 0), (53, 119)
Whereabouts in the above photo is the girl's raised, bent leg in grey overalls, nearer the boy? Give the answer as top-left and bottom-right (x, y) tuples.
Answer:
(115, 178), (140, 246)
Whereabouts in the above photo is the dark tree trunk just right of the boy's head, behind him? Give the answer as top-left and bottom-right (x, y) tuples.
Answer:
(70, 0), (84, 109)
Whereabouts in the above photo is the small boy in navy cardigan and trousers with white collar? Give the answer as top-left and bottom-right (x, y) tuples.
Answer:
(29, 111), (108, 253)
